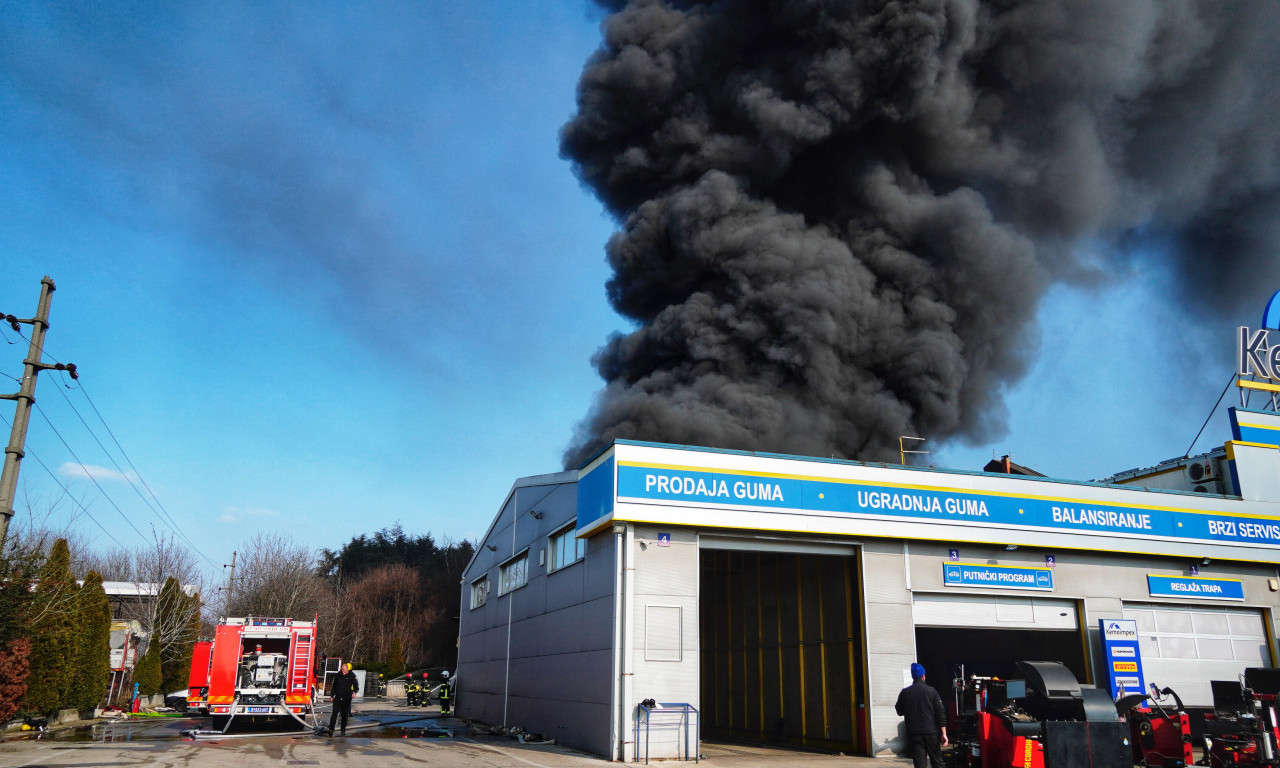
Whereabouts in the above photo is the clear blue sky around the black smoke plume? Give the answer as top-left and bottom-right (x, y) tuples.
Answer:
(0, 0), (1262, 576)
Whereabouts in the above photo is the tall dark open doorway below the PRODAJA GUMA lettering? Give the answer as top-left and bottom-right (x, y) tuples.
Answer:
(699, 549), (868, 754)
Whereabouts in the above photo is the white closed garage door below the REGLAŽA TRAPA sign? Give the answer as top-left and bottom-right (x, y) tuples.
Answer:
(1124, 604), (1271, 707)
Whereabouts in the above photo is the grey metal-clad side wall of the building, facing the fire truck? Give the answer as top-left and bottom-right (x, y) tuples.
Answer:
(458, 473), (614, 754)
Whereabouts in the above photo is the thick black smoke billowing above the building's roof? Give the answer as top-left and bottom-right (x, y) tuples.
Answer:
(562, 0), (1280, 466)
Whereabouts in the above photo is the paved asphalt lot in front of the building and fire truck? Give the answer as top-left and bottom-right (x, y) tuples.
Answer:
(0, 701), (910, 768)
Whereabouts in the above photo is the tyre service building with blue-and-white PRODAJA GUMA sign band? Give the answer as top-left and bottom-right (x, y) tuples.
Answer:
(457, 349), (1280, 762)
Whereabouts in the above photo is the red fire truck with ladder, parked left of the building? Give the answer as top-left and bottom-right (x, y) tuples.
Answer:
(202, 616), (319, 728)
